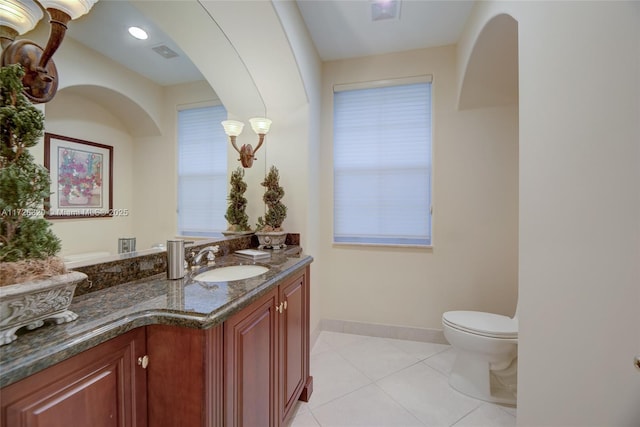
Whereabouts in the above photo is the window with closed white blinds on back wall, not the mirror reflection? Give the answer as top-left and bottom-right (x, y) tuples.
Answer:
(333, 77), (431, 245)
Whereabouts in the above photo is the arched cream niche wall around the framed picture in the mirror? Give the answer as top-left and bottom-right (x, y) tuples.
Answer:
(42, 85), (138, 258)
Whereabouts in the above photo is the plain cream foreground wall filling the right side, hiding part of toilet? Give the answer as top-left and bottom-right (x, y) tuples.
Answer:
(459, 2), (640, 426)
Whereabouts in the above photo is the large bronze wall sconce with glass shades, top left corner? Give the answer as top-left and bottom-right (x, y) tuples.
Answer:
(0, 0), (98, 103)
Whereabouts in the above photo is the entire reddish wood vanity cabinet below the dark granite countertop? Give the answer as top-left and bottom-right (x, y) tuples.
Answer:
(0, 267), (312, 427)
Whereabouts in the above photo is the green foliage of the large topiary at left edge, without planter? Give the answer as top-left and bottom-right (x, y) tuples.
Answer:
(0, 64), (60, 262)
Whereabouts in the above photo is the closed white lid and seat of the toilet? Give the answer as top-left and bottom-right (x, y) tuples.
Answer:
(442, 311), (518, 338)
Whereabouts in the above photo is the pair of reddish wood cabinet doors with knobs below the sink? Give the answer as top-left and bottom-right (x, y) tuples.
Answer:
(224, 268), (312, 427)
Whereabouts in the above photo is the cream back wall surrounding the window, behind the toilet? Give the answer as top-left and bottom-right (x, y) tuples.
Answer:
(315, 46), (518, 330)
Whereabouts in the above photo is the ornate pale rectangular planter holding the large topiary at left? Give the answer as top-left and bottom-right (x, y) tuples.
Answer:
(0, 271), (87, 345)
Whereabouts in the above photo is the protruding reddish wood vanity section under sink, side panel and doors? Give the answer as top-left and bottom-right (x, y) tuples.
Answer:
(147, 268), (312, 427)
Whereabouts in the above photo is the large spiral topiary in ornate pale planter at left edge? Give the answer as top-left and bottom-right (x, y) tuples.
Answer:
(0, 64), (87, 345)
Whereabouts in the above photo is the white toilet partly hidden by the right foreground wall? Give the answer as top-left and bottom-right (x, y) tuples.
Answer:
(442, 308), (518, 406)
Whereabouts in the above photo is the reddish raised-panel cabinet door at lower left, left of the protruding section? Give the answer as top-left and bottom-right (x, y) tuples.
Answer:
(0, 328), (147, 427)
